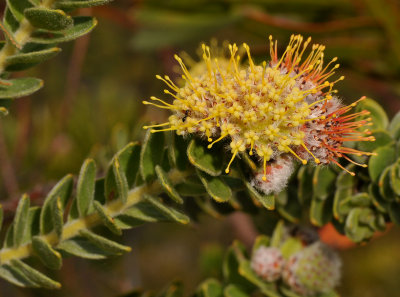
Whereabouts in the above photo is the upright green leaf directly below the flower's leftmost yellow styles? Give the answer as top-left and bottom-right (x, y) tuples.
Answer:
(140, 130), (165, 182)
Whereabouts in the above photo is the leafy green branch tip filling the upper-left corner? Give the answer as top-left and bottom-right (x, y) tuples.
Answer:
(0, 0), (114, 105)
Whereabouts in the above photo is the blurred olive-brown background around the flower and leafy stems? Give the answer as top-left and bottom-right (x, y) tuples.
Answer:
(0, 0), (400, 297)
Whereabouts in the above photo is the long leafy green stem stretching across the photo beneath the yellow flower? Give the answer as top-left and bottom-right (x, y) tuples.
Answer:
(0, 97), (394, 286)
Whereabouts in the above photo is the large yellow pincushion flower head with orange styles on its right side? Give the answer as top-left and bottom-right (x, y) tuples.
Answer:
(143, 35), (374, 187)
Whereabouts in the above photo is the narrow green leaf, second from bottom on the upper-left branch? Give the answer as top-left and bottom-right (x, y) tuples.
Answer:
(6, 47), (61, 71)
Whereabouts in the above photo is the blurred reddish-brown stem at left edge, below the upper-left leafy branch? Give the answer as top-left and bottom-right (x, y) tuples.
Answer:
(0, 123), (19, 198)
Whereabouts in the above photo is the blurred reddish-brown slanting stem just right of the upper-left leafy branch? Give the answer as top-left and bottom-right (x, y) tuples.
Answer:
(61, 8), (92, 126)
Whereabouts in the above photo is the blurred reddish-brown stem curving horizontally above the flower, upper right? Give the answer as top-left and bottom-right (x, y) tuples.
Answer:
(242, 7), (378, 33)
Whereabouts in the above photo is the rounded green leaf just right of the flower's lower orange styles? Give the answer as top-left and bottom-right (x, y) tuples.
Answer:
(368, 146), (396, 182)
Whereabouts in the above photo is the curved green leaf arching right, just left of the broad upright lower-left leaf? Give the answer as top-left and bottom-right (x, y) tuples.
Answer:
(40, 174), (74, 234)
